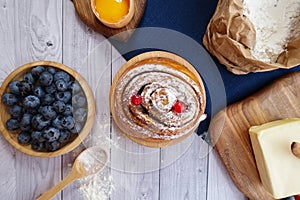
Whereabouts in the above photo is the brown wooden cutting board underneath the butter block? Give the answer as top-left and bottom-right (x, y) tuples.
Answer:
(210, 72), (300, 200)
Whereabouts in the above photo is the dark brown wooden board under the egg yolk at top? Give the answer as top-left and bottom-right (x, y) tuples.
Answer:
(73, 0), (146, 42)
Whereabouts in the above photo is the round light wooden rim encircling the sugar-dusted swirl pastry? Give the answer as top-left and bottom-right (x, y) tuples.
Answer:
(109, 51), (206, 148)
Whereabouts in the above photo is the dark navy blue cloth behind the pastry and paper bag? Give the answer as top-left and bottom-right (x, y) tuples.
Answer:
(112, 0), (300, 138)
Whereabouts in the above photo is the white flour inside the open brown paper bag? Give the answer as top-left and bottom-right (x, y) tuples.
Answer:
(243, 0), (300, 63)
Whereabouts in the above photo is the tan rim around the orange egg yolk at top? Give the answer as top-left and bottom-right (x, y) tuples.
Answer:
(91, 0), (134, 29)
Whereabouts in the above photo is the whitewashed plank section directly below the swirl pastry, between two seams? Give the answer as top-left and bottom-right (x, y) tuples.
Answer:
(159, 134), (208, 199)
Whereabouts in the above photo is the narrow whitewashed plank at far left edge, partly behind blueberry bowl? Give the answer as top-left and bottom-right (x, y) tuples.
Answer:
(0, 0), (17, 199)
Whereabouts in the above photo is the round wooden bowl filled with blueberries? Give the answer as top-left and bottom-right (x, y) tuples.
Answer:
(0, 61), (96, 157)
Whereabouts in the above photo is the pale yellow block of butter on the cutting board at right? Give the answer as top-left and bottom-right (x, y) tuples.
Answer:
(249, 118), (300, 199)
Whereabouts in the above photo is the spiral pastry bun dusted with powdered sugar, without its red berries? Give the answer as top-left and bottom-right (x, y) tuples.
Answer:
(114, 64), (205, 140)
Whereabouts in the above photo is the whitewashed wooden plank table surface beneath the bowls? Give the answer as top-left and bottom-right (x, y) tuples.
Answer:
(0, 0), (245, 200)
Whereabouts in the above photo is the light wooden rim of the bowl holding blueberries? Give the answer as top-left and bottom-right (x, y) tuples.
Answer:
(0, 61), (96, 157)
